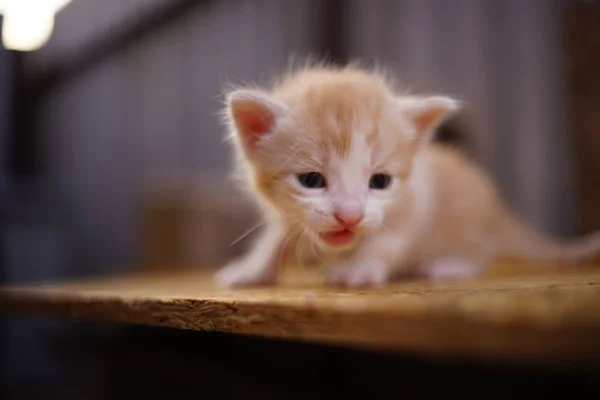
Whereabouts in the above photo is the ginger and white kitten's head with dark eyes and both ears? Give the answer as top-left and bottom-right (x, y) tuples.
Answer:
(227, 68), (458, 248)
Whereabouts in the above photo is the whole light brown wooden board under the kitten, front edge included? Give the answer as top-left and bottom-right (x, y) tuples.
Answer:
(0, 264), (600, 360)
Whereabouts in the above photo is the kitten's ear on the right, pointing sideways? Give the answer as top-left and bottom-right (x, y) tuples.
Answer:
(399, 96), (461, 138)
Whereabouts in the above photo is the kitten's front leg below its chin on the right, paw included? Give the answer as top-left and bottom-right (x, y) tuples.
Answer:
(326, 235), (411, 288)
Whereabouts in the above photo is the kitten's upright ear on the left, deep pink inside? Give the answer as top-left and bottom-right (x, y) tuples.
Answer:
(227, 89), (287, 149)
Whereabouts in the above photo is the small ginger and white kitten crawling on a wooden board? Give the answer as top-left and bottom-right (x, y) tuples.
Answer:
(216, 67), (600, 287)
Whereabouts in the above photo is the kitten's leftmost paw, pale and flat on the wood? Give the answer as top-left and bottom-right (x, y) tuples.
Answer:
(215, 261), (277, 288)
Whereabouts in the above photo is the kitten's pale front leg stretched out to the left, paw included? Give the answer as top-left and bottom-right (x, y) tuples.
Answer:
(215, 225), (286, 287)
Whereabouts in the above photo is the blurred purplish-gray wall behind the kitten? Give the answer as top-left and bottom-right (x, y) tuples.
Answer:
(10, 0), (574, 271)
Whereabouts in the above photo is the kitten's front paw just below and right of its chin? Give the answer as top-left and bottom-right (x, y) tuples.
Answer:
(326, 261), (390, 288)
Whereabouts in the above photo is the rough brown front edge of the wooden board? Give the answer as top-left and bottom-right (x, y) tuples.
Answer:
(0, 293), (600, 363)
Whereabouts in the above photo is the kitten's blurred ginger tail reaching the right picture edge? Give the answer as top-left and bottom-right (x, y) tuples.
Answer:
(499, 211), (600, 263)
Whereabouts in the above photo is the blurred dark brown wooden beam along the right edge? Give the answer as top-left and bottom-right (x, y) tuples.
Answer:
(564, 1), (600, 232)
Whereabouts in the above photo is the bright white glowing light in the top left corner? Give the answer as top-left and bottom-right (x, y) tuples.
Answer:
(0, 0), (71, 51)
